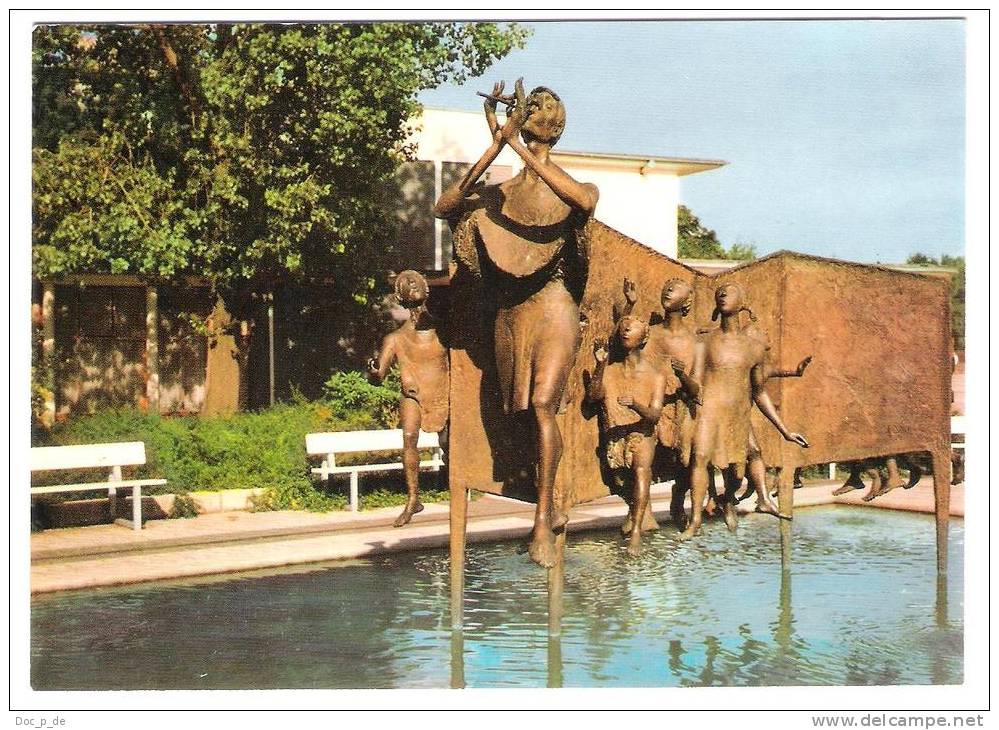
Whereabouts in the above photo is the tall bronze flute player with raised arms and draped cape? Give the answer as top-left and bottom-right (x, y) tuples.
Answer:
(435, 80), (598, 567)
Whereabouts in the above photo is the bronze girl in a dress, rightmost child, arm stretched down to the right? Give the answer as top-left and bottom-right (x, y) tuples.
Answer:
(681, 283), (808, 539)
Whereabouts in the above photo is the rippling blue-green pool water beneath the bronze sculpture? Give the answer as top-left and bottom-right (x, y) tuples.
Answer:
(31, 507), (963, 689)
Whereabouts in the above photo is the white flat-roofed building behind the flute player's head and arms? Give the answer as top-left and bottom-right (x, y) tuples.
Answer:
(414, 109), (725, 270)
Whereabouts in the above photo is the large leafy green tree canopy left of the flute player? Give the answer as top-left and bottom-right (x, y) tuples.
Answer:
(32, 23), (526, 406)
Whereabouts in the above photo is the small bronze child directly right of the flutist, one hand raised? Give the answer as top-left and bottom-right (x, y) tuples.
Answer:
(586, 315), (667, 555)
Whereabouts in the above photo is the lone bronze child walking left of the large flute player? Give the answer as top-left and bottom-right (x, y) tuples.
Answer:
(368, 271), (449, 527)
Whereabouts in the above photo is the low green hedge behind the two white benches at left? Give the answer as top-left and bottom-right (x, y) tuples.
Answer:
(33, 373), (447, 511)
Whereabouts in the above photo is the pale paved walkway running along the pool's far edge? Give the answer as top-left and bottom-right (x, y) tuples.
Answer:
(31, 478), (964, 593)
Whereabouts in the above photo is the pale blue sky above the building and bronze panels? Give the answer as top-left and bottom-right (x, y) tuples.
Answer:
(420, 19), (965, 263)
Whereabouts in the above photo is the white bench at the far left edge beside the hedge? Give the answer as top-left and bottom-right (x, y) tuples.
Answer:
(30, 441), (167, 530)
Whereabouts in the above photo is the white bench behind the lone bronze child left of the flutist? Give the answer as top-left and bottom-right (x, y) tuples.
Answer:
(305, 428), (444, 512)
